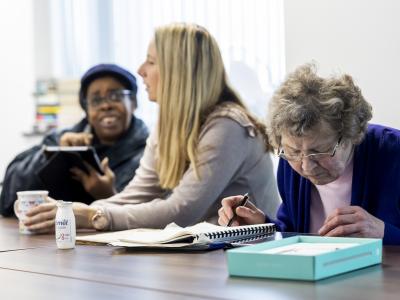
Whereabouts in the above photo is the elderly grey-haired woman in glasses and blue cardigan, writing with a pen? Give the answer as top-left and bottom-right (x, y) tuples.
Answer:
(219, 65), (400, 244)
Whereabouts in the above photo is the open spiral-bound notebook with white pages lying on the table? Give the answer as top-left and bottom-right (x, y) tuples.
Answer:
(76, 222), (275, 250)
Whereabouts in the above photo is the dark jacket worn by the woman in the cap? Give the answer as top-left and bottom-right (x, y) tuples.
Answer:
(0, 117), (148, 216)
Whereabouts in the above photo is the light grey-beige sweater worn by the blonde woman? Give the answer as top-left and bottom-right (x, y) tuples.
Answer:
(91, 104), (280, 230)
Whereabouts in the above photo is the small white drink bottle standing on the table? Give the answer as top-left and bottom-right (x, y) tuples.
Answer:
(55, 201), (76, 249)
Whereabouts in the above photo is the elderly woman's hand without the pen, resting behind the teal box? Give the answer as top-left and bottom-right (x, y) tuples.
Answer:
(318, 206), (385, 238)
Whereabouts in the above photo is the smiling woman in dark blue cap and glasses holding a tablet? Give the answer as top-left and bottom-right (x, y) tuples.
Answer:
(0, 64), (148, 215)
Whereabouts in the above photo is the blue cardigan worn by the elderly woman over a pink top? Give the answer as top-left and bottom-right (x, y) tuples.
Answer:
(267, 124), (400, 245)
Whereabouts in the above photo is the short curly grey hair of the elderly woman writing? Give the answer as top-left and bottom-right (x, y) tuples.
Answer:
(267, 64), (372, 149)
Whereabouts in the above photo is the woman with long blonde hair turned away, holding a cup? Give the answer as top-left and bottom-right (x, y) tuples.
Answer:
(22, 24), (279, 232)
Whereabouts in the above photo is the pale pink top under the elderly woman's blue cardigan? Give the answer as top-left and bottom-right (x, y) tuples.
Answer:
(310, 159), (353, 233)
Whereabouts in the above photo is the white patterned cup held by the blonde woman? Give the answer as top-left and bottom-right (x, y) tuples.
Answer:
(14, 191), (49, 234)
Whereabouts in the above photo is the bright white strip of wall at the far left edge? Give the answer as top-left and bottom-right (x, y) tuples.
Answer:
(0, 0), (34, 181)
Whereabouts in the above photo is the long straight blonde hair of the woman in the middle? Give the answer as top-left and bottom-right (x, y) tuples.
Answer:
(154, 23), (264, 189)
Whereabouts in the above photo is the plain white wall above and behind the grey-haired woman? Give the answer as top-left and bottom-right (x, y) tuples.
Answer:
(284, 0), (400, 128)
